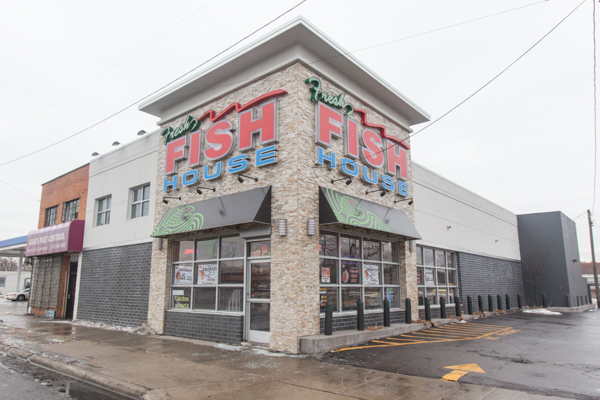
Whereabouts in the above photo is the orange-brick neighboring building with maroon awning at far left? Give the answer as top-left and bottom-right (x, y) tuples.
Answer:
(25, 164), (89, 319)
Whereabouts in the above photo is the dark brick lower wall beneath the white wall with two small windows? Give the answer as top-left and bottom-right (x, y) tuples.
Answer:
(77, 243), (152, 326)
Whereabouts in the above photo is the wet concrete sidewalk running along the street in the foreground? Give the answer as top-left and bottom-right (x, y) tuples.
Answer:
(0, 315), (568, 400)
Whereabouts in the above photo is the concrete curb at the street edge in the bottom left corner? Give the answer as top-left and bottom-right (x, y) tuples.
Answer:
(0, 345), (147, 399)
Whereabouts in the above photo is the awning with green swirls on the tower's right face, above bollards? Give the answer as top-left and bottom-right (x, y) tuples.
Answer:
(319, 187), (421, 240)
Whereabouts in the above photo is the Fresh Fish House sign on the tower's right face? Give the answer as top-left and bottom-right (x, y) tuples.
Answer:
(305, 77), (410, 197)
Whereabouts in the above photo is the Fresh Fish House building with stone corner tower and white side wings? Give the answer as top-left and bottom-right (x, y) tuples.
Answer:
(62, 18), (523, 353)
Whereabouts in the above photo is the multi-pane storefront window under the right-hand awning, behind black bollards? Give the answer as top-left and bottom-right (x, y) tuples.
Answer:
(319, 232), (401, 312)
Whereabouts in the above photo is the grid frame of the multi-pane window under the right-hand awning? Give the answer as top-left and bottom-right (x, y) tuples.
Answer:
(318, 230), (402, 316)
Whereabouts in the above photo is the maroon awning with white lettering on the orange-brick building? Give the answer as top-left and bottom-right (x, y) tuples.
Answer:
(25, 220), (85, 257)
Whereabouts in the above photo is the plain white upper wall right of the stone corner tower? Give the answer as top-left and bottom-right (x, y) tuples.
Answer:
(412, 162), (521, 260)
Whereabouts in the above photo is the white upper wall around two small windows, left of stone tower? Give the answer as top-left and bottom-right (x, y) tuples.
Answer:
(83, 130), (159, 250)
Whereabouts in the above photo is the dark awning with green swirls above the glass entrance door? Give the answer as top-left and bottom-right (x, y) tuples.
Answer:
(152, 186), (271, 237)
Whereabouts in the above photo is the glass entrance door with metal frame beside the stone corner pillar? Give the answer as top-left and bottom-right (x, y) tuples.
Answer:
(246, 261), (271, 343)
